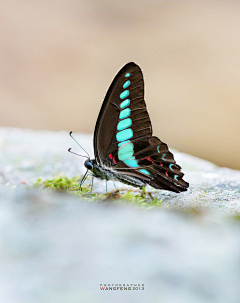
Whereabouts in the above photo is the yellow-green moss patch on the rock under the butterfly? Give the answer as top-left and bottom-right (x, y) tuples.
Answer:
(34, 174), (162, 207)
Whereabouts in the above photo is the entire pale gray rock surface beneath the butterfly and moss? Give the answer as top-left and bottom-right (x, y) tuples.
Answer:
(0, 128), (240, 303)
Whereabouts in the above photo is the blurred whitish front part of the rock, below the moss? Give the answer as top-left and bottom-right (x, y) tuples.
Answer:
(0, 187), (240, 303)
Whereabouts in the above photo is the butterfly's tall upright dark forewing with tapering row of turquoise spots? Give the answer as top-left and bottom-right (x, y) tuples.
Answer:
(94, 62), (152, 164)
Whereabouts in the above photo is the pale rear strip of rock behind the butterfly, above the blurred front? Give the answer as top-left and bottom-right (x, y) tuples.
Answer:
(0, 128), (240, 214)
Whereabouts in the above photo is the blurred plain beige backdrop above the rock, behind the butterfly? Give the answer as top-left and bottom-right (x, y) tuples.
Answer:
(0, 0), (240, 169)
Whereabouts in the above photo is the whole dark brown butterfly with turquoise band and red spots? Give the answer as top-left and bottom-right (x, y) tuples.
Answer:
(70, 62), (189, 193)
